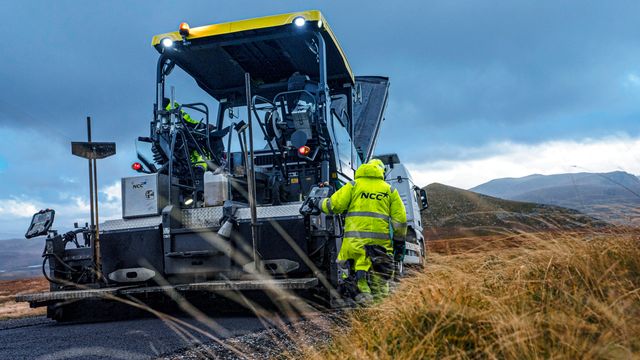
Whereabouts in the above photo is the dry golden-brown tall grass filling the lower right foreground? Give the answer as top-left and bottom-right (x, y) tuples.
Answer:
(306, 232), (640, 359)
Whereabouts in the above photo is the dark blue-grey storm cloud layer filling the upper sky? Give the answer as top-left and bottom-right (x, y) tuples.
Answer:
(0, 1), (640, 136)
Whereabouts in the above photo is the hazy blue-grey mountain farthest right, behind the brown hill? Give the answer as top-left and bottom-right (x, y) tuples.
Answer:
(470, 171), (640, 225)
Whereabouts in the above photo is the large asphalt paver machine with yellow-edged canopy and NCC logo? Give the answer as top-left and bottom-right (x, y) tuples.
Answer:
(19, 11), (400, 319)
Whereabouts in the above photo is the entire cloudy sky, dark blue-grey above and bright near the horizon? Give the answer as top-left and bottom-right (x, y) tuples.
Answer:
(0, 0), (640, 239)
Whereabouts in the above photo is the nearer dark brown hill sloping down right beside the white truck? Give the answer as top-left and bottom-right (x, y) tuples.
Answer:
(422, 183), (608, 239)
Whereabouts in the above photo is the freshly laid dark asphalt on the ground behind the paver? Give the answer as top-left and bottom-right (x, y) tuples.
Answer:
(0, 314), (272, 359)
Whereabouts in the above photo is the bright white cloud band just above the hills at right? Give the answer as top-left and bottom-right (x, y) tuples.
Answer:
(407, 136), (640, 189)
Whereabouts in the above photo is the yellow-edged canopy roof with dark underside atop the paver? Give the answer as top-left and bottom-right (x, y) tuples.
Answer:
(152, 10), (354, 100)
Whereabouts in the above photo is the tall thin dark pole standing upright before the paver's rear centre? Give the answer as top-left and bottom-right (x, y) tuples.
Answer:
(244, 73), (261, 272)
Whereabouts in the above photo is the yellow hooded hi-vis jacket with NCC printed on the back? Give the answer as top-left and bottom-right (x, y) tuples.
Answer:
(322, 159), (407, 271)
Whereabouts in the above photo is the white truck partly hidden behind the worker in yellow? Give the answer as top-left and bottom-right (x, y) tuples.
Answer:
(374, 154), (429, 265)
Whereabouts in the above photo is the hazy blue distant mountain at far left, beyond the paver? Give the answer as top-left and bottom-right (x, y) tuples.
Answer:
(0, 238), (44, 280)
